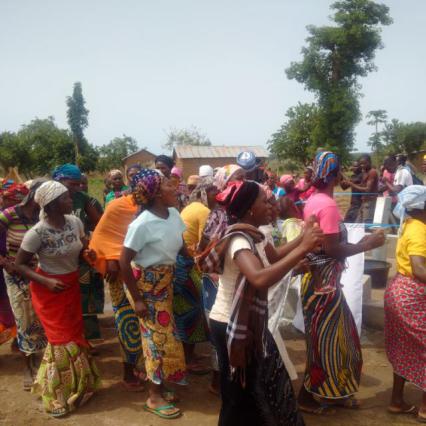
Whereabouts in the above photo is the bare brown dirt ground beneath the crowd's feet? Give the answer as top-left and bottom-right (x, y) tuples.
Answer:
(0, 312), (421, 426)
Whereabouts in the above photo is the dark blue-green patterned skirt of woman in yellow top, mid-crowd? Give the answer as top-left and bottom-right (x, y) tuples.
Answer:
(173, 255), (209, 344)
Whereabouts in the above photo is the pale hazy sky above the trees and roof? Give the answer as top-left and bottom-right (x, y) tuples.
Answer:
(0, 0), (426, 154)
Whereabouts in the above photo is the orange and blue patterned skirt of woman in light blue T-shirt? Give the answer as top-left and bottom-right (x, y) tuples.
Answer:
(130, 265), (186, 385)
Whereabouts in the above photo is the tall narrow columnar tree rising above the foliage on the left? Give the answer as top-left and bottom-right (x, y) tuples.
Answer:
(66, 82), (98, 171)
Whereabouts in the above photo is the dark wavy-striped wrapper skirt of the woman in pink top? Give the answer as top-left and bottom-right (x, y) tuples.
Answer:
(301, 273), (362, 398)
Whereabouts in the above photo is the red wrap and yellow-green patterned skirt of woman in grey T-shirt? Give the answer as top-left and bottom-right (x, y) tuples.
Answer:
(30, 269), (100, 413)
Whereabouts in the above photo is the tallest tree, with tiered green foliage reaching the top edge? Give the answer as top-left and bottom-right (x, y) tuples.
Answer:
(286, 0), (392, 159)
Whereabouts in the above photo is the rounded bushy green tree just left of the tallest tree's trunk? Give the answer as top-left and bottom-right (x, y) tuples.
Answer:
(268, 103), (318, 165)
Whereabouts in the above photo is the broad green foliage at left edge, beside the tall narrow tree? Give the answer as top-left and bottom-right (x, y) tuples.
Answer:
(0, 117), (75, 177)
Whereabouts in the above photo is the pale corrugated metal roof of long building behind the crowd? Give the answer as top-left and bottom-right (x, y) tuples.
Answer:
(174, 145), (269, 158)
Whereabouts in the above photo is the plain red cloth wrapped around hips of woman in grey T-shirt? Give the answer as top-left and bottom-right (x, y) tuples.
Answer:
(30, 268), (88, 346)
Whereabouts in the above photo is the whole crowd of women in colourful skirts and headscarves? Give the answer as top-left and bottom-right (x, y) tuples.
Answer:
(0, 150), (426, 426)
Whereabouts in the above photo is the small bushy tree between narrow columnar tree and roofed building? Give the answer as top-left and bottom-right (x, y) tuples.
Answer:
(97, 135), (139, 172)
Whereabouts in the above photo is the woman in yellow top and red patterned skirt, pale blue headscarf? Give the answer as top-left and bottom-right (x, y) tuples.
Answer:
(385, 185), (426, 423)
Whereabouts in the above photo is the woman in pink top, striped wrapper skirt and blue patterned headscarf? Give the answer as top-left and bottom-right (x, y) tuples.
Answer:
(299, 151), (385, 414)
